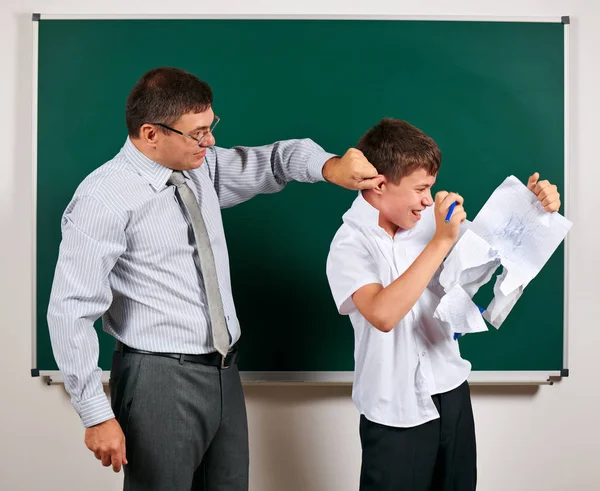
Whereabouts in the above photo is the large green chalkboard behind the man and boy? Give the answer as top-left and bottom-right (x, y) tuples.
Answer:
(35, 18), (565, 380)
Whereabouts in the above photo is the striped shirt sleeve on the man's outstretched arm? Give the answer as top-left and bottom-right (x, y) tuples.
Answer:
(207, 139), (335, 208)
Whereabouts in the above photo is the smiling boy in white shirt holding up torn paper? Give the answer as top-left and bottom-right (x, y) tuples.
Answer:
(327, 119), (560, 491)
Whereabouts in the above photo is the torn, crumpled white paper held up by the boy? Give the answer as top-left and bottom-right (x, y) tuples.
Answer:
(434, 176), (573, 333)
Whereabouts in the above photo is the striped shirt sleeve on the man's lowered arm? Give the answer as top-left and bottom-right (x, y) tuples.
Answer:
(47, 197), (126, 427)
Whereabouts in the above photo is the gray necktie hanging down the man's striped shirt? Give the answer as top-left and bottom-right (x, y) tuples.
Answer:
(167, 171), (229, 356)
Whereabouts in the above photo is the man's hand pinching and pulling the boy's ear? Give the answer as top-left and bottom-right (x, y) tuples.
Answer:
(323, 148), (383, 190)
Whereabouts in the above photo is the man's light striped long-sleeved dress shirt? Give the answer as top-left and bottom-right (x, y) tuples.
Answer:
(48, 139), (333, 427)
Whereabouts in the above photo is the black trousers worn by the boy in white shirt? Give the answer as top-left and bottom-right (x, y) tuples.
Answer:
(360, 382), (477, 491)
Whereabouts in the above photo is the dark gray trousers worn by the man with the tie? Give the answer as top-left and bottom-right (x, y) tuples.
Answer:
(110, 352), (249, 491)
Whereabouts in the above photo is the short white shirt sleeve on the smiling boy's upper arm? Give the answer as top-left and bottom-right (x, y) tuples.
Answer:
(327, 230), (382, 315)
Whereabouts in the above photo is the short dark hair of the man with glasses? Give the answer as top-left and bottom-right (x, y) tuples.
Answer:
(125, 67), (213, 138)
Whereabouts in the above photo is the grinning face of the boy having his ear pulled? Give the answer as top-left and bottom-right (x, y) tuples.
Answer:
(379, 169), (436, 229)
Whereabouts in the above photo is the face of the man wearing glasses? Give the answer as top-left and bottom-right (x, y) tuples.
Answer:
(156, 107), (215, 170)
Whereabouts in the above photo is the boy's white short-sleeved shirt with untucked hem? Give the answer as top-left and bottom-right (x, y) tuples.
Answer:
(327, 192), (471, 427)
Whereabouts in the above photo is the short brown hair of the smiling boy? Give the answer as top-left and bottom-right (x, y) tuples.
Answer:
(356, 118), (442, 184)
